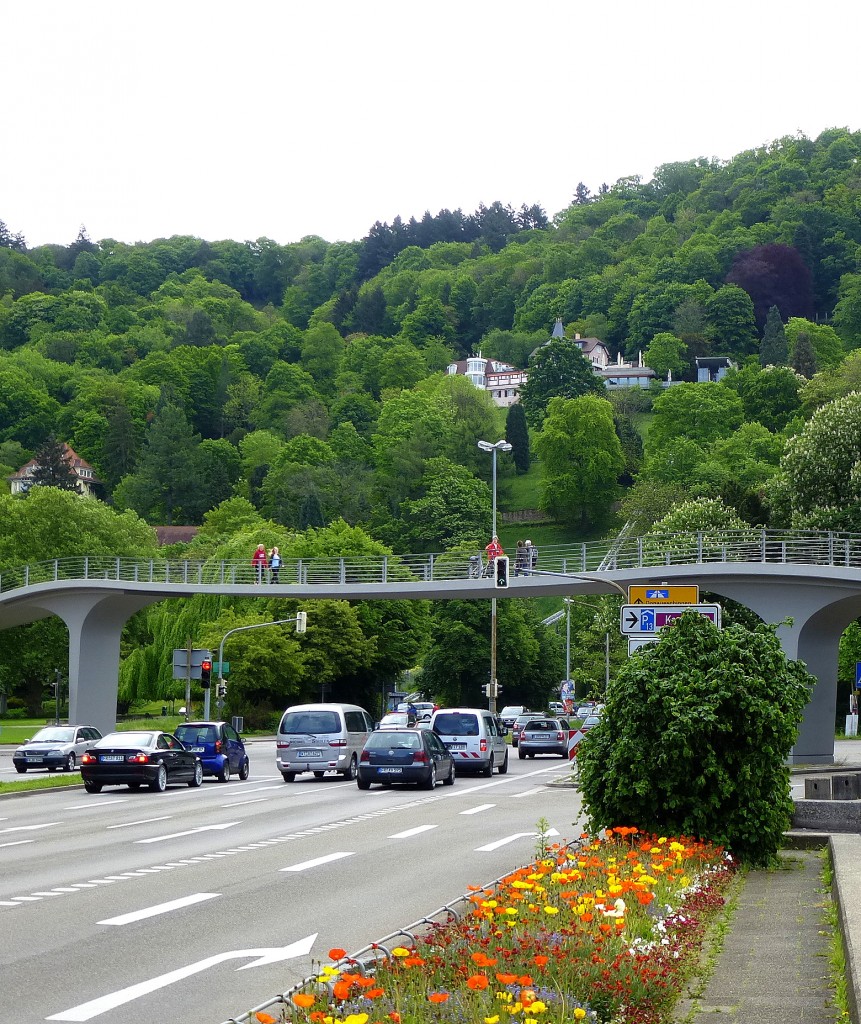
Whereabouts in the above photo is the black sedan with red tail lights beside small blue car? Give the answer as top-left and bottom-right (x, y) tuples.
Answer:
(81, 730), (204, 793)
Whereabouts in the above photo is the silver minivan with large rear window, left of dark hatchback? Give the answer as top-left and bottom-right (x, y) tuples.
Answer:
(275, 703), (374, 782)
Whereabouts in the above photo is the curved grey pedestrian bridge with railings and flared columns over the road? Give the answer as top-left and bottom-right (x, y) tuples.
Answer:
(0, 529), (861, 764)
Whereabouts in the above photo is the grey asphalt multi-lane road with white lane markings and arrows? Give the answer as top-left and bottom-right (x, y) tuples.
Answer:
(0, 741), (580, 1024)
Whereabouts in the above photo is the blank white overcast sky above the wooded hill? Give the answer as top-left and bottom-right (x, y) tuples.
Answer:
(0, 0), (861, 246)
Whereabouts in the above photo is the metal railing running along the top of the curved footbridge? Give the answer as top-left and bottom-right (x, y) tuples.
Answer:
(0, 529), (861, 593)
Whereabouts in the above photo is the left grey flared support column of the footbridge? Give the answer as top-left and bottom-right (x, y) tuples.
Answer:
(41, 591), (153, 733)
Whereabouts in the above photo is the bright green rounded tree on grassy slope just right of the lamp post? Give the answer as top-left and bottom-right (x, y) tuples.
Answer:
(535, 395), (625, 526)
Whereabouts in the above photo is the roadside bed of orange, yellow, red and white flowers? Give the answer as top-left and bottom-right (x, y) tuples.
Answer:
(255, 827), (735, 1024)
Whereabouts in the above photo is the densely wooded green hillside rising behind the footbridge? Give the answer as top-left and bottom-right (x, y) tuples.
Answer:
(0, 129), (861, 720)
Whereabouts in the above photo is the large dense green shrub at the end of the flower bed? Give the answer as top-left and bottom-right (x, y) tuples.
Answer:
(577, 613), (815, 865)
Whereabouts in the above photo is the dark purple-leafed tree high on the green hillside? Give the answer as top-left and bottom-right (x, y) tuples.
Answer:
(727, 245), (813, 332)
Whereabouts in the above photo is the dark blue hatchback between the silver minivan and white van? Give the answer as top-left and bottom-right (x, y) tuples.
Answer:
(356, 729), (455, 790)
